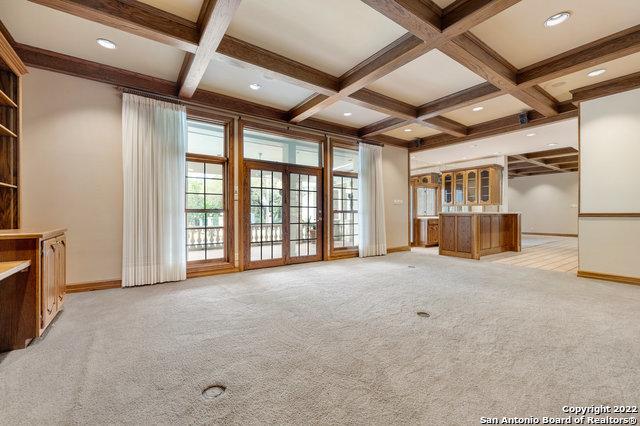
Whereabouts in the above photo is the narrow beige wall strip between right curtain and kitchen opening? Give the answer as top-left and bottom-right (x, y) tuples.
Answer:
(382, 145), (409, 248)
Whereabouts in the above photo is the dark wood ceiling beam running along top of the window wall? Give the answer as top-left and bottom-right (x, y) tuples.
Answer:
(14, 44), (408, 147)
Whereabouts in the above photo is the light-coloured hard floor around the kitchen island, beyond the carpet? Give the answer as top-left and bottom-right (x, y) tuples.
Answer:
(412, 235), (578, 274)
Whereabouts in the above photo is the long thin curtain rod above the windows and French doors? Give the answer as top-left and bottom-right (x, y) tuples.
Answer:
(116, 86), (384, 146)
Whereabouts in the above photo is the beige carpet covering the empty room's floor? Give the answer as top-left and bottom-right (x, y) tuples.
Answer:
(0, 253), (640, 425)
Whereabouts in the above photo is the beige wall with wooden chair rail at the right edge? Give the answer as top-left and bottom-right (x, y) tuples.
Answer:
(579, 89), (640, 278)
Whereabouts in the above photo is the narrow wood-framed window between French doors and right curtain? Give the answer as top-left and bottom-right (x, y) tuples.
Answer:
(331, 147), (359, 250)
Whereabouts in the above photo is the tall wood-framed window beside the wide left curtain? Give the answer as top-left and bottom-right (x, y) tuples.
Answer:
(185, 120), (229, 264)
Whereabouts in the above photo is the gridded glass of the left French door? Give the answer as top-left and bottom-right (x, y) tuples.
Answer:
(249, 170), (284, 262)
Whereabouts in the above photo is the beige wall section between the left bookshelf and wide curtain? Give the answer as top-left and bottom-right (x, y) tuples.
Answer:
(20, 68), (122, 283)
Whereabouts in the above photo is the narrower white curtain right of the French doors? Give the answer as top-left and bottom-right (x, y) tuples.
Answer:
(358, 143), (387, 257)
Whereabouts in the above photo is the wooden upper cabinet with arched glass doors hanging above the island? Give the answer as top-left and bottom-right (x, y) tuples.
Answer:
(442, 165), (502, 206)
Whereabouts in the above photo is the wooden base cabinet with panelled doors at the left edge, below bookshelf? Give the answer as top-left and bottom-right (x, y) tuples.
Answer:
(0, 229), (66, 352)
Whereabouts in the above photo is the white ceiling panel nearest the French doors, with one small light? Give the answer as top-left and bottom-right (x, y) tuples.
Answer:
(199, 54), (313, 110)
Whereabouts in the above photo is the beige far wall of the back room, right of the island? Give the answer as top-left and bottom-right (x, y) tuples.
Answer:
(507, 172), (579, 235)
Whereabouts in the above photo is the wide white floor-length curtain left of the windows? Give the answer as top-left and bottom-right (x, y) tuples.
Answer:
(122, 93), (187, 287)
